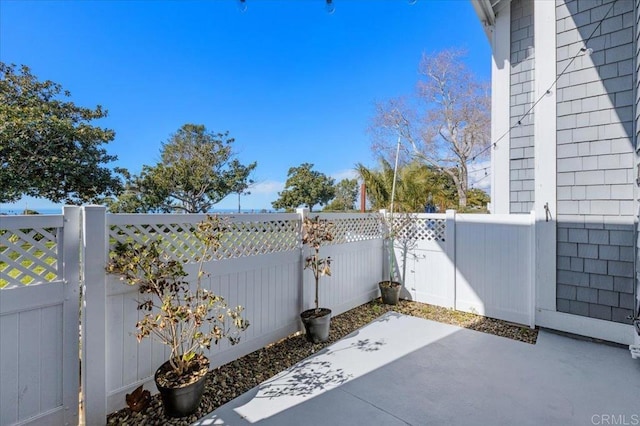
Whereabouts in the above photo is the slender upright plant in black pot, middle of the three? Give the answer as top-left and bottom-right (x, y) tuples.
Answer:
(300, 216), (333, 343)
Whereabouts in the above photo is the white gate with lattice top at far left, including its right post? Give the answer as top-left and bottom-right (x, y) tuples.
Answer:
(0, 207), (80, 426)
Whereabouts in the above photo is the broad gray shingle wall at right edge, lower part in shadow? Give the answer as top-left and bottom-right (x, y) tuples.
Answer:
(556, 0), (640, 323)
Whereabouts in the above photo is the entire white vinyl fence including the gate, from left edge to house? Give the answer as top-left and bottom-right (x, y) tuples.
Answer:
(0, 206), (535, 426)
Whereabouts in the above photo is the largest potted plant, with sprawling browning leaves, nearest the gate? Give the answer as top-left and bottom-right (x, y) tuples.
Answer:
(107, 216), (249, 417)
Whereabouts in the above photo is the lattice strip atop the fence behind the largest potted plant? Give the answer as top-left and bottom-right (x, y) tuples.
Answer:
(109, 220), (300, 262)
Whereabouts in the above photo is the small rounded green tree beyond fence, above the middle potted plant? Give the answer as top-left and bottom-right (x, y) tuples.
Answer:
(271, 163), (335, 211)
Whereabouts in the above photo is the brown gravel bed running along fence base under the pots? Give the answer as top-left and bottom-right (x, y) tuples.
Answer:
(107, 299), (538, 425)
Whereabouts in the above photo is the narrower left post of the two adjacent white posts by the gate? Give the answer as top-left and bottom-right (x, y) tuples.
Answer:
(58, 206), (82, 424)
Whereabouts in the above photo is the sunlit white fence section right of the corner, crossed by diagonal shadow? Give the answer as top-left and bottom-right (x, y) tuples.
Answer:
(394, 210), (535, 327)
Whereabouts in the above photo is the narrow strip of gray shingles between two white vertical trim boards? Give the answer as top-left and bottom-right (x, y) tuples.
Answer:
(509, 0), (534, 213)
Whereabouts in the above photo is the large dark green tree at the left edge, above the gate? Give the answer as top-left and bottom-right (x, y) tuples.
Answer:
(0, 62), (121, 204)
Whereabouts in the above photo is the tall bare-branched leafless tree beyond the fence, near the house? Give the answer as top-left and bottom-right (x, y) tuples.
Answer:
(371, 49), (491, 208)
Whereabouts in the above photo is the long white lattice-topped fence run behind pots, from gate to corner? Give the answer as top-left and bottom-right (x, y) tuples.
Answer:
(82, 207), (382, 424)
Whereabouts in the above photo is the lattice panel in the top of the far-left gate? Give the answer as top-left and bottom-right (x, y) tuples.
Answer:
(0, 228), (59, 288)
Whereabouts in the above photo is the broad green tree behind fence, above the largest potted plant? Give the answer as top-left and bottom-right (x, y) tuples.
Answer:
(111, 124), (256, 213)
